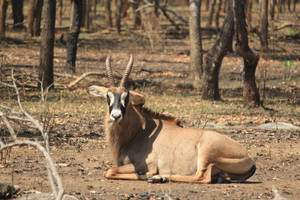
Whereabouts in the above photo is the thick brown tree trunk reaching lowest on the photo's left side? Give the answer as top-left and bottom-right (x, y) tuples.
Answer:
(39, 0), (56, 88)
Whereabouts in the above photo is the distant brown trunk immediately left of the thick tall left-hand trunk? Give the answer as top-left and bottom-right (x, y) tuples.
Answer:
(27, 0), (43, 36)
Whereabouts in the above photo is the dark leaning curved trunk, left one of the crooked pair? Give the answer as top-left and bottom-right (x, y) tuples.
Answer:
(202, 0), (234, 100)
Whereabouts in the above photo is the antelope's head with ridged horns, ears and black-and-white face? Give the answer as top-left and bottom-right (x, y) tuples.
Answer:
(88, 55), (145, 121)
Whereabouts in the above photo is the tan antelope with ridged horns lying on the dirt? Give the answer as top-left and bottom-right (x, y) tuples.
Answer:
(88, 55), (256, 183)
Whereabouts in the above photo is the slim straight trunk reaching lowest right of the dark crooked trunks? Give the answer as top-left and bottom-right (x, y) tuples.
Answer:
(259, 0), (269, 50)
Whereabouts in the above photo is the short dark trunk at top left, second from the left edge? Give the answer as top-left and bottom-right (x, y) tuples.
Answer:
(11, 0), (24, 29)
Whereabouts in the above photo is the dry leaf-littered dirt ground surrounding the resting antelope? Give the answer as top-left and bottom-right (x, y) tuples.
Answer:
(0, 2), (300, 200)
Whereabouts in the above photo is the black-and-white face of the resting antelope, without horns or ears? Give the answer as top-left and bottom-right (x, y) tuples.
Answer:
(106, 89), (129, 121)
